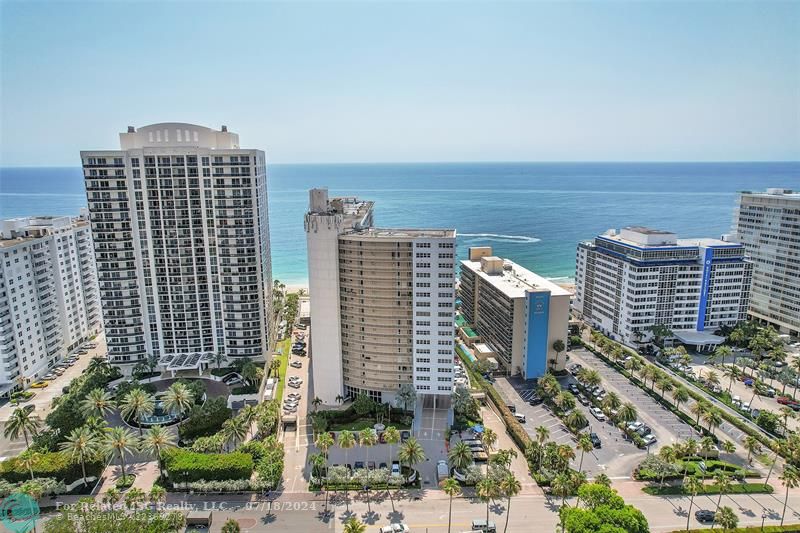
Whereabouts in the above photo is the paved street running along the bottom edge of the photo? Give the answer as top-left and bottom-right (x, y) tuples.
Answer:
(37, 482), (800, 533)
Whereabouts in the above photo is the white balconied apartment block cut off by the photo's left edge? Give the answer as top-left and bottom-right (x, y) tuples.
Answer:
(0, 213), (102, 396)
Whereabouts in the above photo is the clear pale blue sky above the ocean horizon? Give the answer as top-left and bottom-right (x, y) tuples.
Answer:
(0, 0), (800, 166)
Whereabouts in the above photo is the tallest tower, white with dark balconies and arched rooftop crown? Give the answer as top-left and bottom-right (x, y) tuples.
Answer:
(81, 123), (273, 371)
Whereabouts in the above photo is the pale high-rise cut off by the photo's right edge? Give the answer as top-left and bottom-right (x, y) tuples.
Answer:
(733, 189), (800, 336)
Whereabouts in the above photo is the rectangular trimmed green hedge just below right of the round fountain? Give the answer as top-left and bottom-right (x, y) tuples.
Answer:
(164, 448), (254, 483)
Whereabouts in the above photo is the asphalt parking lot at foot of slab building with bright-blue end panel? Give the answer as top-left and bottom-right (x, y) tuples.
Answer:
(495, 370), (647, 479)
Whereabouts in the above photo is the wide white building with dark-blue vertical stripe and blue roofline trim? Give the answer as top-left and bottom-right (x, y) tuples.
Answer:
(573, 226), (753, 351)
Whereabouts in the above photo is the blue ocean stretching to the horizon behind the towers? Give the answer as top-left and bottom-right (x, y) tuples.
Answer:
(0, 162), (800, 285)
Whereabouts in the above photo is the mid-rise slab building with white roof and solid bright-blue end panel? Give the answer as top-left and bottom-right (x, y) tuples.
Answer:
(458, 247), (571, 379)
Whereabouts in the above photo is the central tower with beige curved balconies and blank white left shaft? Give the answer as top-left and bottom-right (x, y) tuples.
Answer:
(305, 189), (456, 404)
